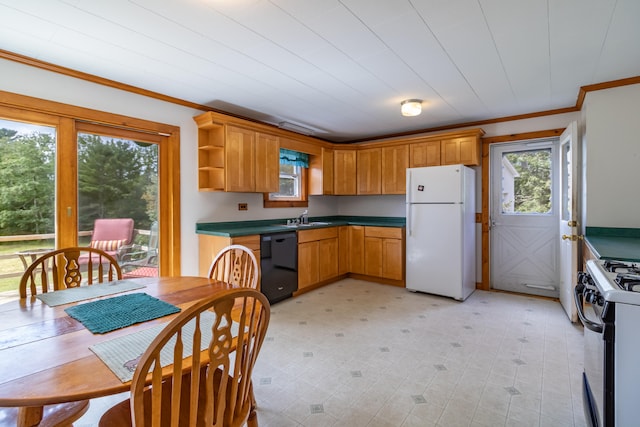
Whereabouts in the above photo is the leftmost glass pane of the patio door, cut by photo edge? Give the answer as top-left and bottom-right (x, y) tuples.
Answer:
(0, 120), (56, 295)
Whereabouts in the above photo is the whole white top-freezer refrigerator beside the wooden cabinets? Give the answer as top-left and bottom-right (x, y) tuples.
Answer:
(406, 165), (476, 301)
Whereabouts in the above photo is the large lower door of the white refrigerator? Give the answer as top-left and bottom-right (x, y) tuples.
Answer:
(406, 204), (468, 300)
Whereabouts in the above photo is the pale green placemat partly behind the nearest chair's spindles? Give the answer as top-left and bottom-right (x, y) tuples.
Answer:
(89, 311), (218, 382)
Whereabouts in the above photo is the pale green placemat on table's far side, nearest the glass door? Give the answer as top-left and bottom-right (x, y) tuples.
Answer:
(36, 279), (150, 307)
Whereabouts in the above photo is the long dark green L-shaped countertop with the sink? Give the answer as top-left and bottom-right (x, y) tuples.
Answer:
(196, 215), (406, 237)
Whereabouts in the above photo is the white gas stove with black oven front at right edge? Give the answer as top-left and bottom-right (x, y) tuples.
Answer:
(575, 260), (640, 427)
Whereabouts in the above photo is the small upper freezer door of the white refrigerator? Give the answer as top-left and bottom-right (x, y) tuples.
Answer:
(407, 165), (465, 203)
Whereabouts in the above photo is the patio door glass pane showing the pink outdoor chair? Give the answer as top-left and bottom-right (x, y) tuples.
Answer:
(78, 133), (158, 276)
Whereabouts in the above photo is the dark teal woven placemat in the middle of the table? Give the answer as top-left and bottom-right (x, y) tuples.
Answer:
(64, 293), (180, 334)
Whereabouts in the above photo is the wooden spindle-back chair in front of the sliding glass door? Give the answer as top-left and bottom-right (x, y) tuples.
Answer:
(20, 247), (122, 298)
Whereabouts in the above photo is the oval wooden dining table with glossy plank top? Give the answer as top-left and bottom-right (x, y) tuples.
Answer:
(0, 277), (233, 427)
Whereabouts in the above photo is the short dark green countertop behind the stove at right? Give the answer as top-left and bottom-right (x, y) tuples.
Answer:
(585, 227), (640, 261)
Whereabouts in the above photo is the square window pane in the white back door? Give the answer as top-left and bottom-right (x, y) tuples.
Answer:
(501, 148), (552, 214)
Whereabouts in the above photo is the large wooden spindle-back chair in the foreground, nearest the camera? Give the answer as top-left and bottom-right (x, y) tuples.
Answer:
(99, 288), (270, 427)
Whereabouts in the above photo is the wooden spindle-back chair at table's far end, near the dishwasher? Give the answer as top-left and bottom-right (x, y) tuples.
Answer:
(209, 245), (259, 289)
